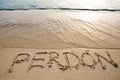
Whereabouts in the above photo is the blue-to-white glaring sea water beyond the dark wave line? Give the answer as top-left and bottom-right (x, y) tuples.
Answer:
(0, 0), (120, 10)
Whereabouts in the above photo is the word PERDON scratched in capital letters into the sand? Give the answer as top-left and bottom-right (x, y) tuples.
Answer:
(8, 50), (118, 73)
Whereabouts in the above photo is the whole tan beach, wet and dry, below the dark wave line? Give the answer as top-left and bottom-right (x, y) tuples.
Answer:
(0, 10), (120, 80)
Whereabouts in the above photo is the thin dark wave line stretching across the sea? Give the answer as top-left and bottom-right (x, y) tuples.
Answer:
(0, 8), (120, 11)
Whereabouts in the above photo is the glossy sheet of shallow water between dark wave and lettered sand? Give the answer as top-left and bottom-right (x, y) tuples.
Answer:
(0, 10), (120, 49)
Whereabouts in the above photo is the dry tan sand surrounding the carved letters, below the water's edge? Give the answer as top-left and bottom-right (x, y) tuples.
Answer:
(0, 48), (120, 80)
